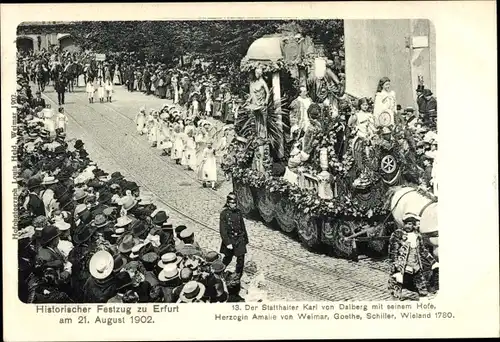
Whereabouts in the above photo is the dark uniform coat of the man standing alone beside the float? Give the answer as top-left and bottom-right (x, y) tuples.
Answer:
(219, 208), (248, 256)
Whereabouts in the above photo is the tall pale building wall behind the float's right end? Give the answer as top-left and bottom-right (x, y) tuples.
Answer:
(344, 19), (437, 108)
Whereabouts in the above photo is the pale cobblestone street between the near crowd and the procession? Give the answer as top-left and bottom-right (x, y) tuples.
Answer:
(45, 83), (400, 301)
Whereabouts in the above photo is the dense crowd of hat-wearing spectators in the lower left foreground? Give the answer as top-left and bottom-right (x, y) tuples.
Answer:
(17, 79), (266, 303)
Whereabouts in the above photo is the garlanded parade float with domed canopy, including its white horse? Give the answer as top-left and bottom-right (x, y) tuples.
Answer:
(223, 34), (437, 259)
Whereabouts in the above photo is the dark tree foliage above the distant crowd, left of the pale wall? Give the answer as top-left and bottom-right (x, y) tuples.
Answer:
(68, 20), (343, 65)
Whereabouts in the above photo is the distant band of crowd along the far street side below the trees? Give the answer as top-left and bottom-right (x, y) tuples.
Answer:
(18, 50), (245, 124)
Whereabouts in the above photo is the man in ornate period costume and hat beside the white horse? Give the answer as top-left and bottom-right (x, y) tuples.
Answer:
(389, 213), (439, 298)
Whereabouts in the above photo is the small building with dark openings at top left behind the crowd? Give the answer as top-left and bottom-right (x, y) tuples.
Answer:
(16, 21), (79, 52)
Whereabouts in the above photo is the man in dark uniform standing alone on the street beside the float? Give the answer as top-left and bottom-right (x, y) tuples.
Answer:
(219, 192), (248, 278)
